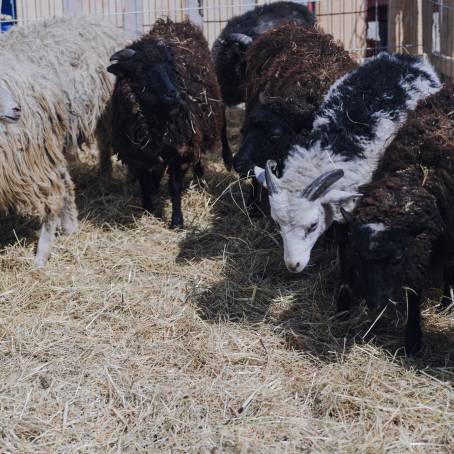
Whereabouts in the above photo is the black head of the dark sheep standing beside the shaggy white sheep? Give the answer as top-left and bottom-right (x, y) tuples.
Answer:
(107, 44), (182, 110)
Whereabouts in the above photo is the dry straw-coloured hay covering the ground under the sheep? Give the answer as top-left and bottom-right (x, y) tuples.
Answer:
(0, 112), (454, 453)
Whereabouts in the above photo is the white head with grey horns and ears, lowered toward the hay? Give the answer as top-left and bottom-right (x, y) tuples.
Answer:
(254, 161), (360, 273)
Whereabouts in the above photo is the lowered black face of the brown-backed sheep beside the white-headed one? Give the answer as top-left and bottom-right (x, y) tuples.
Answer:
(233, 106), (301, 177)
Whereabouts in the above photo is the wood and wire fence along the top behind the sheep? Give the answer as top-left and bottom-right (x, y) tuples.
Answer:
(0, 0), (454, 77)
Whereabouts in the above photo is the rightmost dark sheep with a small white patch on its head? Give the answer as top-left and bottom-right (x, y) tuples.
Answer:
(337, 83), (454, 353)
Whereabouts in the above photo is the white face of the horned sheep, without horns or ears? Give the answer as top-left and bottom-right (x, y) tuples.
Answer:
(269, 190), (329, 273)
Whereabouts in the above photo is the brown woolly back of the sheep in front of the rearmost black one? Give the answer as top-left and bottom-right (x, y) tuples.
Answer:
(245, 22), (357, 119)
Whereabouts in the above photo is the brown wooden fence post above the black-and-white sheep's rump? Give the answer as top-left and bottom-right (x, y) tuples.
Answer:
(388, 0), (425, 54)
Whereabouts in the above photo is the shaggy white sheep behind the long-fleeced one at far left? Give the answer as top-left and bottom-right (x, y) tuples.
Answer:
(0, 16), (128, 151)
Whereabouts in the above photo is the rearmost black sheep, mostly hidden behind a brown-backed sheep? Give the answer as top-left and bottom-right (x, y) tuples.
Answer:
(212, 2), (314, 106)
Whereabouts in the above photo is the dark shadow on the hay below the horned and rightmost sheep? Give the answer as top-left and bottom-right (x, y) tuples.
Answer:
(177, 165), (454, 368)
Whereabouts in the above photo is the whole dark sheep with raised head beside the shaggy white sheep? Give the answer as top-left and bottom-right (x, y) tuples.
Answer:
(109, 20), (230, 226)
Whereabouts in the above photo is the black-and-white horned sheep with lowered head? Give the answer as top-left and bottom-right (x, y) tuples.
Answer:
(255, 53), (441, 273)
